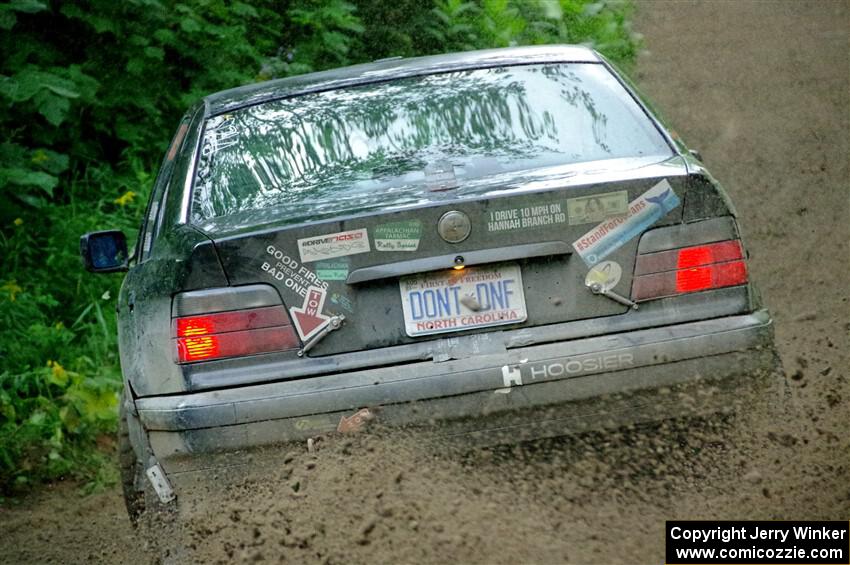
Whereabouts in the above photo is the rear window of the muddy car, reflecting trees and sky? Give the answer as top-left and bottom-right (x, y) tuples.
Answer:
(192, 63), (672, 222)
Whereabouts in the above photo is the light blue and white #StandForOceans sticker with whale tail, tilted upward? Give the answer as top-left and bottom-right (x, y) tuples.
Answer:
(573, 179), (679, 267)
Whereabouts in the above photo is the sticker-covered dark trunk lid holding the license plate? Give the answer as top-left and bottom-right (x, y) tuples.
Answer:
(207, 157), (687, 356)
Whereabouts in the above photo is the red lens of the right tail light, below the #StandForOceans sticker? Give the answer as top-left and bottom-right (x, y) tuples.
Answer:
(632, 239), (748, 302)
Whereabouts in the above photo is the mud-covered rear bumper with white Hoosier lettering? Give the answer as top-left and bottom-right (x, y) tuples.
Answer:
(136, 310), (778, 473)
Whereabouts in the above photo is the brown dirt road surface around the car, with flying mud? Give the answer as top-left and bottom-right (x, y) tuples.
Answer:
(0, 0), (850, 563)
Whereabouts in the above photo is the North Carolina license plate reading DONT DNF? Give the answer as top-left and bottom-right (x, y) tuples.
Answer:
(399, 264), (528, 337)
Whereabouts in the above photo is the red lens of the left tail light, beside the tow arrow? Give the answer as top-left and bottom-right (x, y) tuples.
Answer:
(174, 306), (298, 363)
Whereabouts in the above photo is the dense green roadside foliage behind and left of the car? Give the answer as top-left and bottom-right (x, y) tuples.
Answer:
(0, 0), (636, 491)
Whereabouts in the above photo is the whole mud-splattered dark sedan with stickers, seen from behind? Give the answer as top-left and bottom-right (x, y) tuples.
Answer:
(82, 46), (777, 513)
